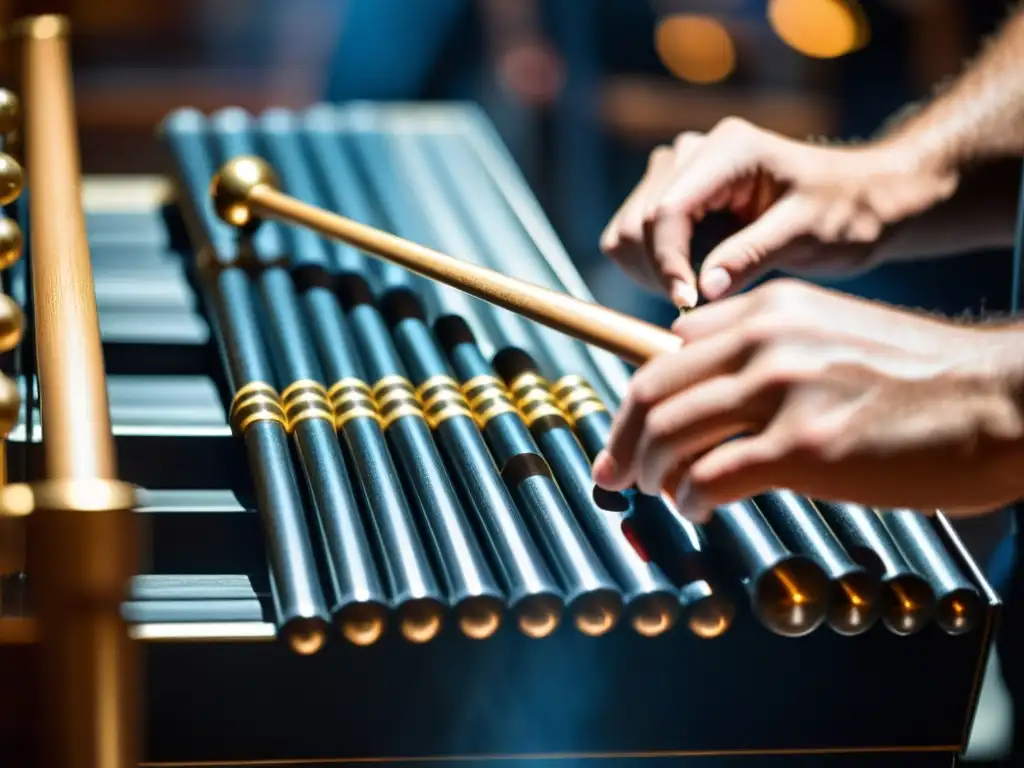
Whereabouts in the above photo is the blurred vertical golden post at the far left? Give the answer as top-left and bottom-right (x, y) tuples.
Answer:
(13, 15), (140, 768)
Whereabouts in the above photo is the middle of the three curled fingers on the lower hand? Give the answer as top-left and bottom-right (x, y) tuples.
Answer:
(635, 376), (770, 494)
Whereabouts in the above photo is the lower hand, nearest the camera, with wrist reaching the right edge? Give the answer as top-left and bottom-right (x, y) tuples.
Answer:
(594, 281), (1024, 519)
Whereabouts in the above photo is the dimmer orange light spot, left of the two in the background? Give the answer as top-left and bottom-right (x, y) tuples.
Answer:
(654, 13), (736, 85)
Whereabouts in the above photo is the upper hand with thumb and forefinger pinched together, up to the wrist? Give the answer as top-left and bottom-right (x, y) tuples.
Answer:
(601, 119), (957, 306)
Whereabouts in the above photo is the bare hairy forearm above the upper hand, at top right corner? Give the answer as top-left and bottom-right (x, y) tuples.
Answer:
(883, 7), (1024, 172)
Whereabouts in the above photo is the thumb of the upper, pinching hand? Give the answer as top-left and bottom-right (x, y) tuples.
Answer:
(700, 196), (813, 301)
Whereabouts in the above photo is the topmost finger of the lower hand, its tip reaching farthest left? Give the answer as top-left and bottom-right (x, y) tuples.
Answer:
(593, 335), (746, 490)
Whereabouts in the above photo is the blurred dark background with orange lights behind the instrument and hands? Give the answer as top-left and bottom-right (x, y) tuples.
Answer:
(0, 0), (1024, 759)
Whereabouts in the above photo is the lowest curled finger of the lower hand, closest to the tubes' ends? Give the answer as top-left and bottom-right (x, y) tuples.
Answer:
(676, 432), (787, 521)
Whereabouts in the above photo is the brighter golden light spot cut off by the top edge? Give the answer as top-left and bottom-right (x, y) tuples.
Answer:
(768, 0), (869, 58)
